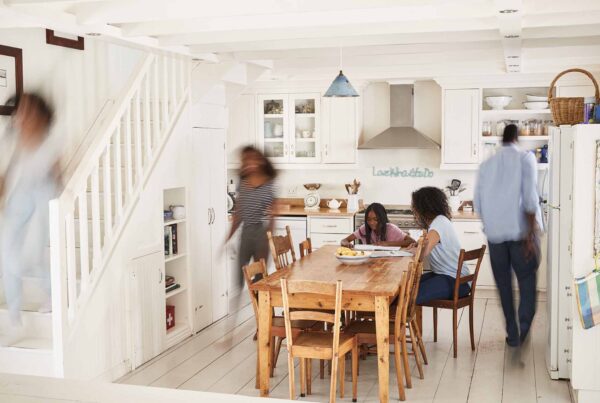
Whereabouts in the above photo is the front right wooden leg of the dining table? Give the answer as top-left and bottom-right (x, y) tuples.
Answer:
(375, 297), (390, 403)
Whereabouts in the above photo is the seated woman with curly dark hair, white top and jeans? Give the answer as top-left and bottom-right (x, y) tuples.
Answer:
(412, 187), (471, 304)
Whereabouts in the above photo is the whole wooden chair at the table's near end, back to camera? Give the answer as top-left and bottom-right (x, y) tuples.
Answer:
(281, 278), (358, 403)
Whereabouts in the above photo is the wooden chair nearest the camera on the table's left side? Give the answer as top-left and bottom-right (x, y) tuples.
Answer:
(242, 259), (319, 388)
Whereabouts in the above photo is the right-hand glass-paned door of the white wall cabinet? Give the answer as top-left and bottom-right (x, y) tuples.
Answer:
(288, 94), (321, 163)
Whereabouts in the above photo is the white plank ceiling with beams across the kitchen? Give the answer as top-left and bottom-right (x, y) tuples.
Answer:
(0, 0), (600, 80)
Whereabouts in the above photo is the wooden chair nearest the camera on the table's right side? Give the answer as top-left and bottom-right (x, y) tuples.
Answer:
(344, 262), (415, 400)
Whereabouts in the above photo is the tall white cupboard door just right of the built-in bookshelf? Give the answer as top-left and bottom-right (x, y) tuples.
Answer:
(190, 128), (229, 331)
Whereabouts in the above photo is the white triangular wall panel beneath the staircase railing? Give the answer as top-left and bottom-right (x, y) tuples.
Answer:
(65, 108), (191, 381)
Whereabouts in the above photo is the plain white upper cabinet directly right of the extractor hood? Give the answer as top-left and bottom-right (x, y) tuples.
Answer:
(442, 88), (481, 169)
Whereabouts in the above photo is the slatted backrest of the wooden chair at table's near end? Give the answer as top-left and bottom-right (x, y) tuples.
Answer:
(281, 278), (342, 357)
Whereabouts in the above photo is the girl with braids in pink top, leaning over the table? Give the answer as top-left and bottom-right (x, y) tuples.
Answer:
(341, 203), (415, 246)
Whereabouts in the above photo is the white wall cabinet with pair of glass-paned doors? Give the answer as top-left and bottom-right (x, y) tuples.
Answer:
(256, 93), (321, 163)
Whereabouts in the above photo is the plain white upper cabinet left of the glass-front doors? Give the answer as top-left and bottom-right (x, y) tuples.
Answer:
(227, 94), (256, 167)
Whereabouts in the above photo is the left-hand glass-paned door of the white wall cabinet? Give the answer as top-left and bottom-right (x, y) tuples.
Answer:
(258, 94), (289, 163)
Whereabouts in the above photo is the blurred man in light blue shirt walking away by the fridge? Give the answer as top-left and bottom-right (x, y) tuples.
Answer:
(473, 125), (541, 347)
